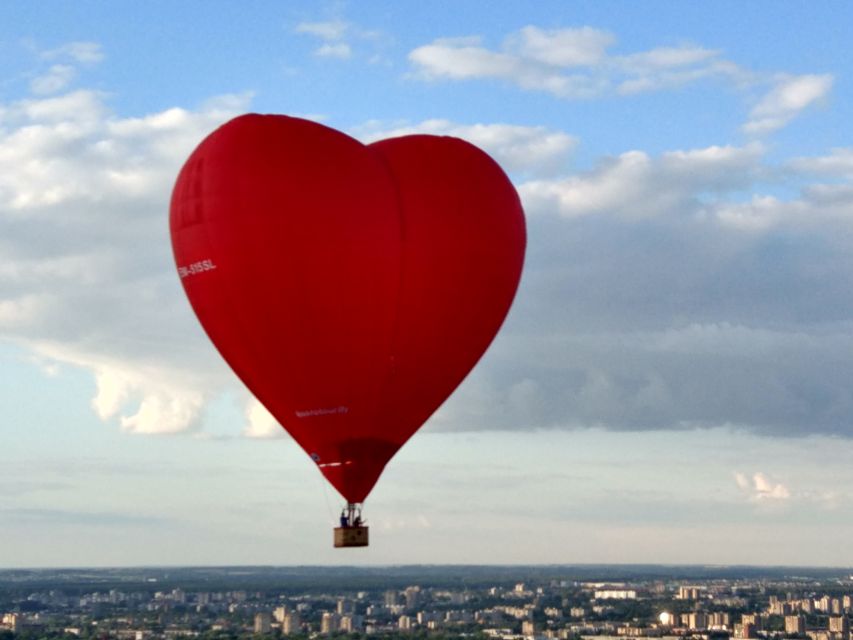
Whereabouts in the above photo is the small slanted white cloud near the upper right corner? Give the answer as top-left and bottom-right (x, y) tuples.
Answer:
(743, 74), (834, 135)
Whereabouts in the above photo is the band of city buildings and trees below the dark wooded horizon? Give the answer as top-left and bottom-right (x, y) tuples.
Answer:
(0, 577), (853, 640)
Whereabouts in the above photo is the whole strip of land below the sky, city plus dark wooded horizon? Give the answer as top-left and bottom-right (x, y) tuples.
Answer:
(0, 565), (853, 640)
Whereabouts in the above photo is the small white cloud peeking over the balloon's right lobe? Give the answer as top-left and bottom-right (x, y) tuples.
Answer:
(355, 119), (577, 176)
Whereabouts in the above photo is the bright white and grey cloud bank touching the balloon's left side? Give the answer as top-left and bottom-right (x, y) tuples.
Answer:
(0, 87), (247, 433)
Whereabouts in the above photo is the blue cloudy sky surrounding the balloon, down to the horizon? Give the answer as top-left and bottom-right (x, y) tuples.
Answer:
(0, 0), (853, 567)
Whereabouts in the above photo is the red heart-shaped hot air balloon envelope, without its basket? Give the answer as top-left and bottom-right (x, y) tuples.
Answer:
(170, 114), (526, 544)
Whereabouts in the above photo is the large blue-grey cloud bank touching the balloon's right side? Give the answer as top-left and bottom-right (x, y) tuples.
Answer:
(432, 138), (853, 437)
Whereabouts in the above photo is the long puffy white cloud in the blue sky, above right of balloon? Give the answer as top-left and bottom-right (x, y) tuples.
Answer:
(409, 26), (744, 99)
